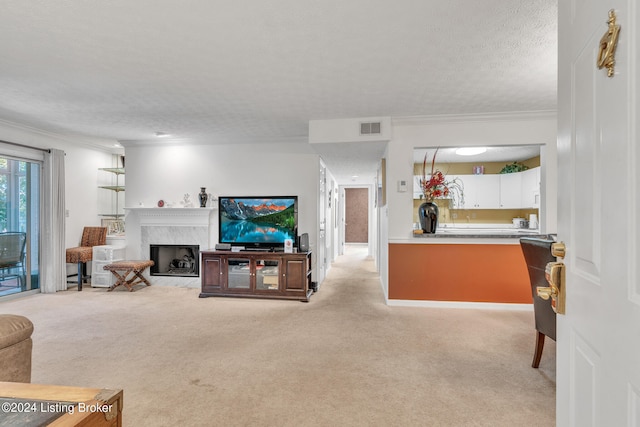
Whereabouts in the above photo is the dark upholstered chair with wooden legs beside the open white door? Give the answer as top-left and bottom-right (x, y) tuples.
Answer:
(520, 237), (556, 368)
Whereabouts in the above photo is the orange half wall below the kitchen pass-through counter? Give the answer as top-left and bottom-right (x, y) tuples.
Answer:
(389, 244), (532, 304)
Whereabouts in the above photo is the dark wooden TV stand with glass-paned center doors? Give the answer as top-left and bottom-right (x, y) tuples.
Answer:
(200, 250), (313, 302)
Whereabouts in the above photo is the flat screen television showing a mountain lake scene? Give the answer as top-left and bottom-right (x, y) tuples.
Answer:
(218, 196), (298, 249)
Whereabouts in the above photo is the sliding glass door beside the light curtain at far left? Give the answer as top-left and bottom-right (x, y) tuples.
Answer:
(0, 157), (42, 297)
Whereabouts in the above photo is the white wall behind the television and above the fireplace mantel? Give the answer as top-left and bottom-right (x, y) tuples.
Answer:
(125, 143), (320, 277)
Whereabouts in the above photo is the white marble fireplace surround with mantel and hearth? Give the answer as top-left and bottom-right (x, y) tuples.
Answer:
(126, 208), (213, 288)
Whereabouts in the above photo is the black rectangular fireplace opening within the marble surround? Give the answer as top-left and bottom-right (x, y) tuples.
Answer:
(149, 245), (200, 277)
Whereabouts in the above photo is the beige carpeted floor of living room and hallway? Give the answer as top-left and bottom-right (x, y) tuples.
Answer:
(0, 247), (555, 427)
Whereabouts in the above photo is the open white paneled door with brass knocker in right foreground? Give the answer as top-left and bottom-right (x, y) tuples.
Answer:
(556, 0), (640, 427)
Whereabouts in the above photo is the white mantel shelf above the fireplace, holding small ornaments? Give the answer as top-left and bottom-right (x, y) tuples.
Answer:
(124, 208), (214, 227)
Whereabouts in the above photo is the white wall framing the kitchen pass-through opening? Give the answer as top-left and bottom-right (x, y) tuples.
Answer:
(387, 114), (557, 241)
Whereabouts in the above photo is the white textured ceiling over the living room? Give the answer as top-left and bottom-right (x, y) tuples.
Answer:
(0, 0), (557, 183)
